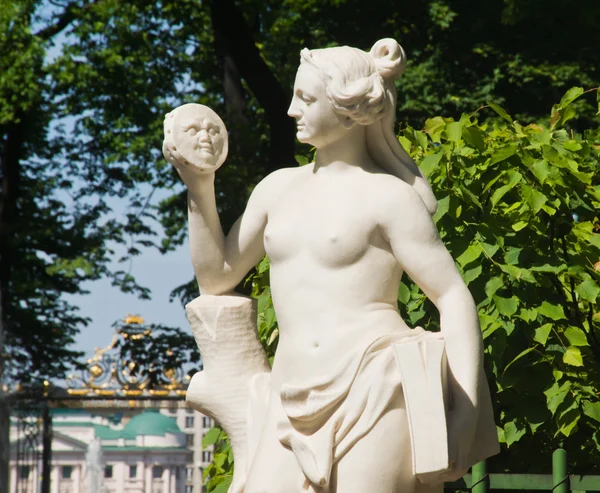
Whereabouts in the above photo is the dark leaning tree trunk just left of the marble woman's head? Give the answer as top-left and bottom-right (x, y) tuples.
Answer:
(210, 0), (296, 172)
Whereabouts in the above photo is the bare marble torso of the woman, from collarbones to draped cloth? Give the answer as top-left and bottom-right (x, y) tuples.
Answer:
(264, 167), (407, 380)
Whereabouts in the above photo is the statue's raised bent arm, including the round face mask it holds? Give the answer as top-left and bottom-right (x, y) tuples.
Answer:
(163, 103), (288, 295)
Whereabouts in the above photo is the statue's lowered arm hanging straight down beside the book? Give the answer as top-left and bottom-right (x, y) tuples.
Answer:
(381, 184), (483, 466)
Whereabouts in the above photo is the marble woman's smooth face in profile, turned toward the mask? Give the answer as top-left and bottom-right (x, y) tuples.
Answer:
(288, 64), (347, 149)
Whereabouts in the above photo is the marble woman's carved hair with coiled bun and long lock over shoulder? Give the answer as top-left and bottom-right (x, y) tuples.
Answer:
(300, 38), (437, 215)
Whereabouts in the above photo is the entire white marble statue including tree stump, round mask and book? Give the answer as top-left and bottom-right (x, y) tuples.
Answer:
(163, 39), (498, 493)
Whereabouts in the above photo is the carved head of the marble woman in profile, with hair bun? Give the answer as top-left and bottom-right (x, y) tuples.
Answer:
(288, 39), (406, 148)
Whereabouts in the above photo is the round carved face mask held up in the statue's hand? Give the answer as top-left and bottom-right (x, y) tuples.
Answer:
(165, 104), (227, 168)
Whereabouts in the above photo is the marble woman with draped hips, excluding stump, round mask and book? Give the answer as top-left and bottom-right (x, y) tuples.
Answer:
(164, 39), (497, 493)
